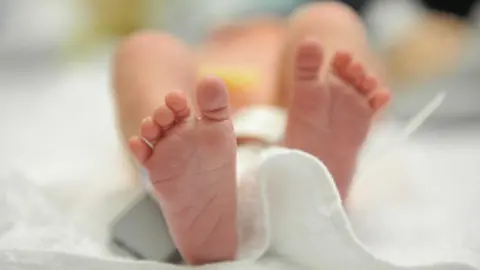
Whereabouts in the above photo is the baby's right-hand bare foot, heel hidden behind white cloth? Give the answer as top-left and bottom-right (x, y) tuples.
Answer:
(285, 40), (389, 197)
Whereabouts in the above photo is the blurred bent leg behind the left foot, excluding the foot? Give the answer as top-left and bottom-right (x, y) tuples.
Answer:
(113, 32), (197, 141)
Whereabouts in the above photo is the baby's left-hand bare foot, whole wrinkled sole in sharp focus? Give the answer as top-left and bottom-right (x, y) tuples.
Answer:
(130, 79), (237, 264)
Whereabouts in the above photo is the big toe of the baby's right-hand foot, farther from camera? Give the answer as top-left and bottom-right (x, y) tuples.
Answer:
(294, 39), (324, 81)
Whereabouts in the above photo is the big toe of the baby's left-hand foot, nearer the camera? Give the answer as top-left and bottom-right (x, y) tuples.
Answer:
(197, 77), (230, 121)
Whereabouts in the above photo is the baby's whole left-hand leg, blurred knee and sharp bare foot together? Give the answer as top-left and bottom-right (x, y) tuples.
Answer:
(114, 33), (236, 264)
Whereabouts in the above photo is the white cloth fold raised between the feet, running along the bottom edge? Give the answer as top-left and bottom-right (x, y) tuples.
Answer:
(0, 149), (474, 270)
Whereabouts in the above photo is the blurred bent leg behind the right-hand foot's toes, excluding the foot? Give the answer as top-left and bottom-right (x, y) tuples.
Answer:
(278, 2), (386, 106)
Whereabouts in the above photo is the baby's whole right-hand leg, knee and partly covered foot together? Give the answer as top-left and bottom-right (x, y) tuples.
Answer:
(281, 3), (389, 197)
